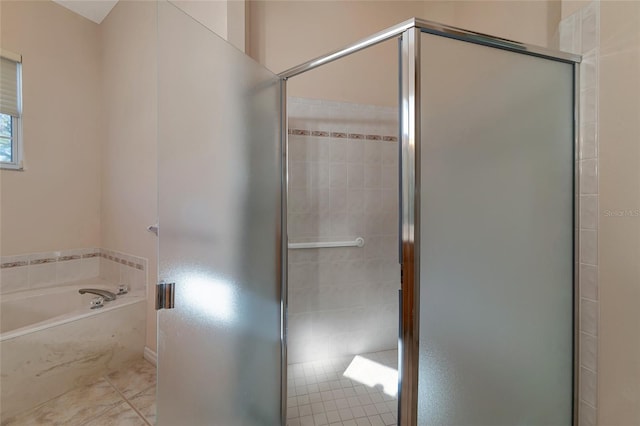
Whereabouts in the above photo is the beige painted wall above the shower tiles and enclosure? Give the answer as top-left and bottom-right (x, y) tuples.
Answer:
(247, 0), (560, 105)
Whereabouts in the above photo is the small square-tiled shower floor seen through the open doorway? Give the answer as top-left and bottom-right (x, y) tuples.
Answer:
(287, 350), (398, 426)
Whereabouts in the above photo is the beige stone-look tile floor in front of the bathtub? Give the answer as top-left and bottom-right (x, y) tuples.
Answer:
(2, 359), (156, 426)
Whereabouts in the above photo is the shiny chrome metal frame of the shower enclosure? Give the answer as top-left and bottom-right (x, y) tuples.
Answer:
(278, 18), (582, 426)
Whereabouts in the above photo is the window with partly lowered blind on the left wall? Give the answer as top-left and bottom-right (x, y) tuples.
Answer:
(0, 50), (22, 170)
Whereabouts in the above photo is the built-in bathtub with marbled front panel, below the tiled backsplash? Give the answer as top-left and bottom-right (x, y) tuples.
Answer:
(0, 279), (146, 422)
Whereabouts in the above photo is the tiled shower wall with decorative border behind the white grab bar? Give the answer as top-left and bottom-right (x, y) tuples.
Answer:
(288, 98), (400, 363)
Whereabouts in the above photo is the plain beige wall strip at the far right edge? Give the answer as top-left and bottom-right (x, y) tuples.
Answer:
(598, 1), (640, 425)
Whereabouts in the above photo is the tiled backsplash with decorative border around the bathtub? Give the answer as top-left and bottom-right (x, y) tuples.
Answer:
(0, 248), (147, 294)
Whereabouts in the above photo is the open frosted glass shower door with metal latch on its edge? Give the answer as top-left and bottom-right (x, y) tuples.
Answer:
(157, 2), (282, 426)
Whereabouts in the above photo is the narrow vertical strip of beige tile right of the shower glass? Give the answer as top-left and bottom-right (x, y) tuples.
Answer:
(559, 1), (600, 425)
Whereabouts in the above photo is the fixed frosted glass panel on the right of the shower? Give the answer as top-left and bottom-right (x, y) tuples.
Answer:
(417, 33), (574, 425)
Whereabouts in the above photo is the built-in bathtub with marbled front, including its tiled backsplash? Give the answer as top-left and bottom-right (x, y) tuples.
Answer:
(0, 249), (147, 421)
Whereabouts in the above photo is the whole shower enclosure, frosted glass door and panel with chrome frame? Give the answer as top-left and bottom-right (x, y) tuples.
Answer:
(158, 2), (579, 426)
